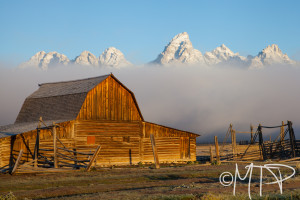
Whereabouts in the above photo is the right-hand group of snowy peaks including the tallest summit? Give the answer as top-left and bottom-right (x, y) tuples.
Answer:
(151, 32), (296, 69)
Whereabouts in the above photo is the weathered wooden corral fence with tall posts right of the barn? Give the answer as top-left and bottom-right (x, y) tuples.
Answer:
(210, 121), (300, 162)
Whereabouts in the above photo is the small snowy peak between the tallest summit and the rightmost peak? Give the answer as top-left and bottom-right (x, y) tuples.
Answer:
(204, 44), (247, 65)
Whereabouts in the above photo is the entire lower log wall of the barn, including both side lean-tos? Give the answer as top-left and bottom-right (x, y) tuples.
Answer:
(0, 120), (196, 167)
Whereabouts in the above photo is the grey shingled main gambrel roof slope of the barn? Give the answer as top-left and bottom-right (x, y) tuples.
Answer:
(15, 75), (110, 123)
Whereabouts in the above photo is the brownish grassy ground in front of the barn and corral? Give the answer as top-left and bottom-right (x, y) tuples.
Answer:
(0, 145), (300, 200)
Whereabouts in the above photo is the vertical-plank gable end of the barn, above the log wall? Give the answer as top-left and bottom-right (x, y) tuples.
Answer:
(76, 75), (143, 121)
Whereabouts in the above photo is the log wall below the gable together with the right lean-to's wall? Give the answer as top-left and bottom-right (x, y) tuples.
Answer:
(75, 120), (196, 166)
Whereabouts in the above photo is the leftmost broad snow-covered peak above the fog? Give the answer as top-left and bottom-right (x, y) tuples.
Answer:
(20, 51), (70, 70)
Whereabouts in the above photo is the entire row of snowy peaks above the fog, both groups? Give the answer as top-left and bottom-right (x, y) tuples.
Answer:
(20, 32), (298, 70)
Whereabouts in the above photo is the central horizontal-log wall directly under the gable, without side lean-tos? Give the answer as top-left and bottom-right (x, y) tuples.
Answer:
(75, 121), (141, 165)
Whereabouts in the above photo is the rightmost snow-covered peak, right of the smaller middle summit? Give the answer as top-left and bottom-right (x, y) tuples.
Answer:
(248, 44), (296, 69)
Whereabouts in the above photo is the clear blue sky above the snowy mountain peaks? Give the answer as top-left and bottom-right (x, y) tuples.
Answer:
(0, 0), (300, 65)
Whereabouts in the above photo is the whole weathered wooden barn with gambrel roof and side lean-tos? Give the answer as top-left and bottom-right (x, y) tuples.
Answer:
(0, 74), (199, 168)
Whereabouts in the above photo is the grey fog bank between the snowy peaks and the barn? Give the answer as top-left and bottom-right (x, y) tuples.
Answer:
(0, 66), (300, 142)
